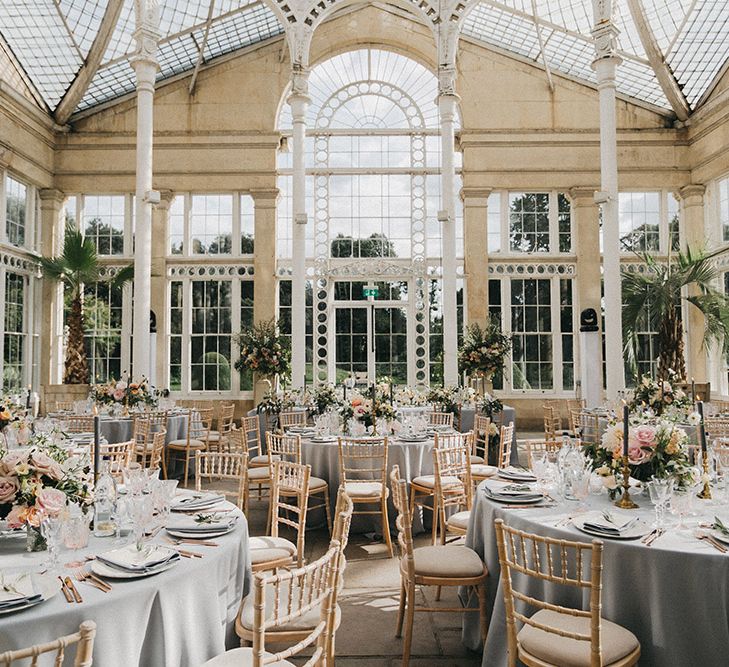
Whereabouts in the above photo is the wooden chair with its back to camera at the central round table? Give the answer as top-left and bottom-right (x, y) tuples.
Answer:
(338, 437), (394, 558)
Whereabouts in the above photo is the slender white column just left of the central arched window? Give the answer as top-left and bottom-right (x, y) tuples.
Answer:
(287, 65), (309, 388)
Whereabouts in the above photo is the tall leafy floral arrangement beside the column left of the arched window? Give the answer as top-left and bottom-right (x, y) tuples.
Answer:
(235, 319), (291, 378)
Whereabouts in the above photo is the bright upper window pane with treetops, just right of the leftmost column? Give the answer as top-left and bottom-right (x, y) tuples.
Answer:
(190, 195), (233, 255)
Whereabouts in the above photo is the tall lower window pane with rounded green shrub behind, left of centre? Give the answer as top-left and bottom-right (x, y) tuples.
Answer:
(190, 280), (232, 391)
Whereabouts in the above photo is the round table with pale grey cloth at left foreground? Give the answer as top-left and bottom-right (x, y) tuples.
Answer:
(0, 511), (251, 667)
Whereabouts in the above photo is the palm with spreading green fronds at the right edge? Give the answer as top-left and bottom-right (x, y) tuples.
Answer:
(623, 248), (729, 381)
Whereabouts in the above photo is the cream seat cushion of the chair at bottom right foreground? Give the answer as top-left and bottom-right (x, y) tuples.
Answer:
(517, 609), (640, 667)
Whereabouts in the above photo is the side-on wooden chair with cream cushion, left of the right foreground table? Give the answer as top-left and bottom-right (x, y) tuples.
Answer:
(390, 466), (488, 667)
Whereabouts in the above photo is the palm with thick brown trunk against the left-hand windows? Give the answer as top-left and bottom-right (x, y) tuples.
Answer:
(40, 223), (134, 384)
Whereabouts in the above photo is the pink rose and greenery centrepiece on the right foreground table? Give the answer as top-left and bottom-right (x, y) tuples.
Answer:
(582, 412), (701, 497)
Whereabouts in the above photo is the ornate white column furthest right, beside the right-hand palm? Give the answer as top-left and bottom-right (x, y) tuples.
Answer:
(592, 0), (625, 399)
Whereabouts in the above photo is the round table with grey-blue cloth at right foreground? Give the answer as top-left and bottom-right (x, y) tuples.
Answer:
(463, 487), (729, 667)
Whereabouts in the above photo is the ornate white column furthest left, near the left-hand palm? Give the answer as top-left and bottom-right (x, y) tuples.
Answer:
(131, 0), (160, 378)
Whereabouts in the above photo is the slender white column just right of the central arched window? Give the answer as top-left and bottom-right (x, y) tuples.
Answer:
(438, 67), (458, 385)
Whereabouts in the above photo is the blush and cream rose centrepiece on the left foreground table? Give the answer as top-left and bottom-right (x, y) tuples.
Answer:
(0, 444), (92, 548)
